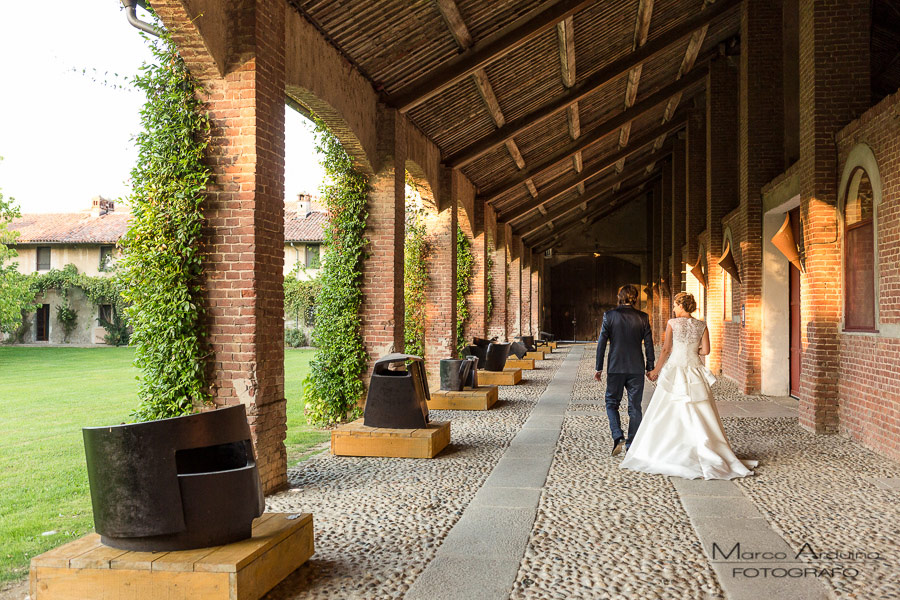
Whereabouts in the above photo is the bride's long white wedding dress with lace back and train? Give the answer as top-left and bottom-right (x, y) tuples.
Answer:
(621, 317), (757, 479)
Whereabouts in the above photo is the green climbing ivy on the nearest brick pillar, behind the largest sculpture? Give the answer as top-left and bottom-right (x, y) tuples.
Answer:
(120, 19), (210, 421)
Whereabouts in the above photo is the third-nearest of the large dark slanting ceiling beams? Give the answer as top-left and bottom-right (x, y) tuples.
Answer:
(479, 75), (705, 202)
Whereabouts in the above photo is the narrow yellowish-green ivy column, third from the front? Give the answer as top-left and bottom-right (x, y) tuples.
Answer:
(403, 208), (428, 357)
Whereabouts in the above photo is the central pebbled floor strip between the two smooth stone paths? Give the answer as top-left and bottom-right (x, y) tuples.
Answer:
(511, 352), (722, 600)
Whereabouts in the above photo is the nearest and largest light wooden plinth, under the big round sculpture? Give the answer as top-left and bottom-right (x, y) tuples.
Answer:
(31, 513), (313, 600)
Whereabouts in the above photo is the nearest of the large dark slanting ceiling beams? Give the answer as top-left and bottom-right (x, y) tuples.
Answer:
(387, 0), (595, 113)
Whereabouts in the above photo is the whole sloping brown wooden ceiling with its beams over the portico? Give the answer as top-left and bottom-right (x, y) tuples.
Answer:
(288, 0), (740, 249)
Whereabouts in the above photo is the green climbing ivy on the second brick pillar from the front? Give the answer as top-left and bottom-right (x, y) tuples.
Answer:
(303, 118), (369, 426)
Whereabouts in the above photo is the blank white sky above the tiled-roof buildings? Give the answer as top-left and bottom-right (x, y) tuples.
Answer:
(0, 0), (323, 213)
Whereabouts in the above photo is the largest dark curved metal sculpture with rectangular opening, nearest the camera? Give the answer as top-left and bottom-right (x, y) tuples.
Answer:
(82, 405), (265, 552)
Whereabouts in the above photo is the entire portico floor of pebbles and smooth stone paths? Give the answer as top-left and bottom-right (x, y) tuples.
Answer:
(269, 346), (900, 599)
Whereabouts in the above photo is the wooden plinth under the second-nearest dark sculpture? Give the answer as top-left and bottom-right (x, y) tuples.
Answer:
(331, 420), (450, 458)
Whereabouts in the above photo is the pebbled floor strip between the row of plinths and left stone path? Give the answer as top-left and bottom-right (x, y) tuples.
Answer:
(266, 349), (566, 600)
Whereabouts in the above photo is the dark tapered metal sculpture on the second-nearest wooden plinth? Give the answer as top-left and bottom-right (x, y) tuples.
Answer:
(363, 354), (431, 429)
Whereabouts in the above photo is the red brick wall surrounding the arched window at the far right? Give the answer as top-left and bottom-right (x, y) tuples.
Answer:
(834, 93), (900, 460)
